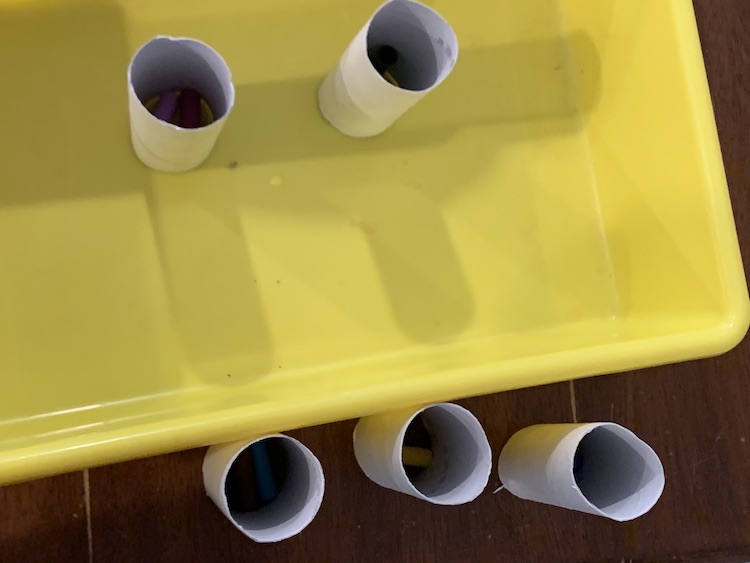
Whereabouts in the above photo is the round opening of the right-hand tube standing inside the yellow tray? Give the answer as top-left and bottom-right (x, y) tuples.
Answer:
(367, 0), (457, 92)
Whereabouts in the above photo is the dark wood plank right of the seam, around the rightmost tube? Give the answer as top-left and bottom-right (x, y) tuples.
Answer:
(575, 354), (750, 561)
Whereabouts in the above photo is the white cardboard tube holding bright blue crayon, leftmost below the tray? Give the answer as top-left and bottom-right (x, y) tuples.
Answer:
(203, 434), (325, 543)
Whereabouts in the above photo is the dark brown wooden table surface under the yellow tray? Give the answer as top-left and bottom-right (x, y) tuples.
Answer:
(0, 0), (750, 563)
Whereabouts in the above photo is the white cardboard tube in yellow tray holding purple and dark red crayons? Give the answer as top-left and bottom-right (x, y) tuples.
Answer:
(128, 36), (234, 172)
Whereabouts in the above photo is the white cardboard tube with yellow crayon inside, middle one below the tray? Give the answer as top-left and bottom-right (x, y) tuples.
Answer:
(354, 403), (492, 505)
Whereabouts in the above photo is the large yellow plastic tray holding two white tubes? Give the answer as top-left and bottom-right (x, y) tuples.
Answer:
(0, 0), (749, 482)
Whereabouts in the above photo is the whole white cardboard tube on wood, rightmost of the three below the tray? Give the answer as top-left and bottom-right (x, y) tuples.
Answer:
(498, 422), (664, 522)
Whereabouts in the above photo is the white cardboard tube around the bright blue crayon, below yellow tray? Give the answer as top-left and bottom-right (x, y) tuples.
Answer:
(203, 434), (325, 543)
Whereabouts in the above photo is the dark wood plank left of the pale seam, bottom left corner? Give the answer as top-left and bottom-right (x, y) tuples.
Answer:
(0, 472), (89, 563)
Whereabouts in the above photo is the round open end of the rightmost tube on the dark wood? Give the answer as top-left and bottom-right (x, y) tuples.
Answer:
(573, 426), (664, 520)
